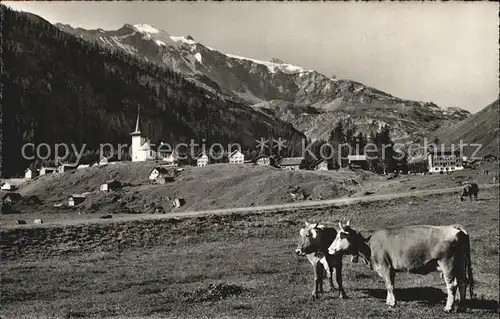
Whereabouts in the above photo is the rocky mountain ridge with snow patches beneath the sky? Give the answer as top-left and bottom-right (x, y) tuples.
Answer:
(56, 24), (470, 140)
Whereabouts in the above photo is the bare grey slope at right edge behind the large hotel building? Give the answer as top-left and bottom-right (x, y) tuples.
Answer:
(433, 100), (500, 157)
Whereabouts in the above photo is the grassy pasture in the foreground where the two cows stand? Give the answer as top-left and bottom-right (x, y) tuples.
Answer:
(0, 189), (499, 318)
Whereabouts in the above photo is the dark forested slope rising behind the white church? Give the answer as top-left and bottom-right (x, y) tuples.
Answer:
(2, 6), (304, 176)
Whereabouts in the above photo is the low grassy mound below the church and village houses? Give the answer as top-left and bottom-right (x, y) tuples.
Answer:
(8, 162), (378, 219)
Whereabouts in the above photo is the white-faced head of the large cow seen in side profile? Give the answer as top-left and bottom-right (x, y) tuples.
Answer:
(328, 221), (370, 262)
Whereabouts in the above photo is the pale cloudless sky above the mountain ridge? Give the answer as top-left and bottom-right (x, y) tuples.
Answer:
(3, 1), (499, 113)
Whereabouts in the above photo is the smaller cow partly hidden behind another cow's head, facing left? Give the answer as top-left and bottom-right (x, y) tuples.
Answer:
(295, 222), (347, 299)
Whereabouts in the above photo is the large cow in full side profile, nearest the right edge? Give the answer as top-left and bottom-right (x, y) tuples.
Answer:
(328, 222), (474, 312)
